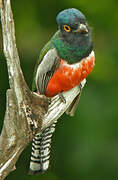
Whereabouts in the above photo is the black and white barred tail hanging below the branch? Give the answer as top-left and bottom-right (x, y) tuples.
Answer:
(29, 121), (57, 174)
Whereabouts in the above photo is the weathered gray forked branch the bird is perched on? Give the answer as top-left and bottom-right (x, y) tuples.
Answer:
(0, 0), (85, 180)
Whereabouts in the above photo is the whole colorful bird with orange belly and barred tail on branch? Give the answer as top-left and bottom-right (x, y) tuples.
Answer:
(29, 8), (95, 174)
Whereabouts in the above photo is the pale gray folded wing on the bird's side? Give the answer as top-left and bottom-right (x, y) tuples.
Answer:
(35, 48), (60, 94)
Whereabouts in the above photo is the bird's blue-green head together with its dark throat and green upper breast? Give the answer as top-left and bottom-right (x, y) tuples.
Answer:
(53, 8), (93, 62)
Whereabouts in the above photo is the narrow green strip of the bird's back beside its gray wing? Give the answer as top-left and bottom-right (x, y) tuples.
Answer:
(32, 41), (54, 91)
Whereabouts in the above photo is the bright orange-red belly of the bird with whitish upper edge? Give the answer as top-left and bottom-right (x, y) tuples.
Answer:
(45, 53), (95, 97)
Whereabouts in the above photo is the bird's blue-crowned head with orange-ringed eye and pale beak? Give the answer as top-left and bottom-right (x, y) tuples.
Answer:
(56, 8), (90, 41)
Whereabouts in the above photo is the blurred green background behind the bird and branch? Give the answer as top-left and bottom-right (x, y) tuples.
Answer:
(0, 0), (118, 180)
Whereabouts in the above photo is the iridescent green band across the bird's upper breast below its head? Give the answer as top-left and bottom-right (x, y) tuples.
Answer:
(51, 30), (93, 64)
